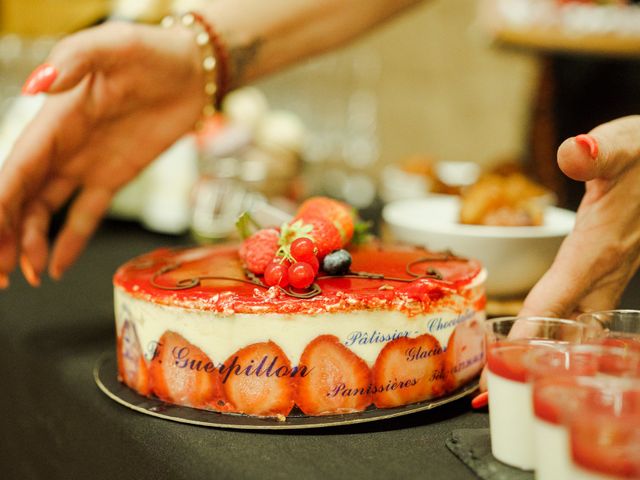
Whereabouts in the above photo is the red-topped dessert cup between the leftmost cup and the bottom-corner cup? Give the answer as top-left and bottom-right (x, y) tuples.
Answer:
(528, 344), (640, 480)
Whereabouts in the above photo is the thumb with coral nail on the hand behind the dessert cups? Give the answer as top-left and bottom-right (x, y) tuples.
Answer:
(558, 115), (640, 181)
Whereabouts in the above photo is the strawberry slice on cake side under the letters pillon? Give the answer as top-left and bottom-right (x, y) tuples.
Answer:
(219, 341), (296, 417)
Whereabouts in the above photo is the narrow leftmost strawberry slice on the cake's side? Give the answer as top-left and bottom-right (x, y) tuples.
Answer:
(116, 320), (151, 395)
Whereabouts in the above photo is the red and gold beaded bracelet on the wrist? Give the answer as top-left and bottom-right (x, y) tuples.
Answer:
(162, 12), (229, 126)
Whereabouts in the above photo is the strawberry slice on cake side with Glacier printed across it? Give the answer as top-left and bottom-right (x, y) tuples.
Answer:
(372, 334), (446, 408)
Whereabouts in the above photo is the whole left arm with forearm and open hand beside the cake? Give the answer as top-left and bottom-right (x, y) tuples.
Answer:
(0, 0), (430, 288)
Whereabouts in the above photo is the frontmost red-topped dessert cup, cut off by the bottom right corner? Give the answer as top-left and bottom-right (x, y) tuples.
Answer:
(567, 379), (640, 480)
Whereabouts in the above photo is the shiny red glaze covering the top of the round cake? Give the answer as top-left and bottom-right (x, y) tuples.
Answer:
(114, 245), (482, 314)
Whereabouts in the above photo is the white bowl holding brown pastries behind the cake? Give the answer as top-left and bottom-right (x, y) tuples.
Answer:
(382, 195), (575, 296)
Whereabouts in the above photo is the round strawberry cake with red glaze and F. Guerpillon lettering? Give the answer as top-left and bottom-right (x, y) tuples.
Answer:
(114, 244), (486, 420)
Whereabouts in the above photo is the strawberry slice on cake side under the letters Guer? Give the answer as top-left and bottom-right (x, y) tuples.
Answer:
(150, 331), (227, 410)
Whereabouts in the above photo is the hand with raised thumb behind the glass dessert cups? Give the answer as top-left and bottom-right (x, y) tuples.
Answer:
(520, 116), (640, 318)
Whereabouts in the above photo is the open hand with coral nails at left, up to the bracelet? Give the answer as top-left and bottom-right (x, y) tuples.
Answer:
(0, 23), (206, 287)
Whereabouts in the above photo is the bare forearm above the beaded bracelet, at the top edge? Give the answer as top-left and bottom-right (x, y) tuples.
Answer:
(202, 0), (420, 86)
